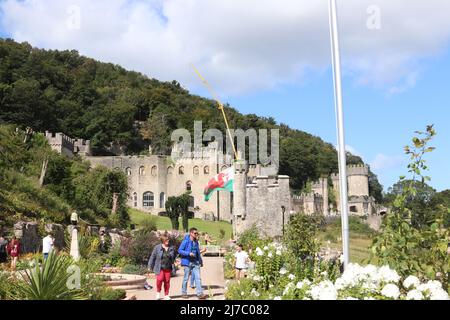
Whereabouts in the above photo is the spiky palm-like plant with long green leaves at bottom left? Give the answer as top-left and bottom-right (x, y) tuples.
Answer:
(15, 252), (87, 300)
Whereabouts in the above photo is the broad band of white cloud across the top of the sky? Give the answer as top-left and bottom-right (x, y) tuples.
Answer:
(0, 0), (450, 95)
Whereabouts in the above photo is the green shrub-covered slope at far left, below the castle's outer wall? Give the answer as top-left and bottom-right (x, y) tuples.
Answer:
(0, 125), (128, 226)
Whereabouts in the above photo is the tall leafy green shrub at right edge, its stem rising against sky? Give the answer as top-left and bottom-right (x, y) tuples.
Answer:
(372, 126), (450, 289)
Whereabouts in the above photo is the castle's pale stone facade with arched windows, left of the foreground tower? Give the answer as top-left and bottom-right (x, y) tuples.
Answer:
(86, 146), (231, 221)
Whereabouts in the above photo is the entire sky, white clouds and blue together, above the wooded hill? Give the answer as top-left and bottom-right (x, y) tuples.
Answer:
(0, 0), (450, 190)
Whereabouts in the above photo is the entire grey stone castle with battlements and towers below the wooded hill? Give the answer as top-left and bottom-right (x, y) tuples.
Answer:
(45, 132), (374, 236)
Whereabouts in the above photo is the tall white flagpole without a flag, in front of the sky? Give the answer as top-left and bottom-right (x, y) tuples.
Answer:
(329, 0), (349, 268)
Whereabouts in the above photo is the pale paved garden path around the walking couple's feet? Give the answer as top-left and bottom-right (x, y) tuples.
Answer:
(127, 257), (225, 300)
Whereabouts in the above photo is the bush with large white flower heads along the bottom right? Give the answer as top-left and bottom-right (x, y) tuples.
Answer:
(230, 251), (450, 300)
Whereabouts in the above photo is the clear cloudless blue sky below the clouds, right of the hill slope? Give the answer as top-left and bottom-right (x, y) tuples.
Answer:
(215, 49), (450, 190)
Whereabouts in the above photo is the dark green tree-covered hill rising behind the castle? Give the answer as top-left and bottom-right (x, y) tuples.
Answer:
(0, 39), (381, 198)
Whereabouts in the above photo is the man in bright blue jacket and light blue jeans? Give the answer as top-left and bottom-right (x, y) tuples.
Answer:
(178, 228), (208, 300)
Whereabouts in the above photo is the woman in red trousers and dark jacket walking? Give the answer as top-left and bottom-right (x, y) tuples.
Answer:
(148, 235), (176, 300)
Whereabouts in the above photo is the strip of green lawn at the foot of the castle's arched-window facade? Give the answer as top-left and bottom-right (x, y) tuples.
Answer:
(128, 209), (233, 245)
